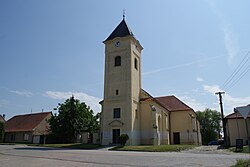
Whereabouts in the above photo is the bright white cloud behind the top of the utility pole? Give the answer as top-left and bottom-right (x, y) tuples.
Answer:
(203, 85), (250, 115)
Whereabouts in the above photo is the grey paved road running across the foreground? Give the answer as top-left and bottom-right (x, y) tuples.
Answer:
(0, 145), (250, 167)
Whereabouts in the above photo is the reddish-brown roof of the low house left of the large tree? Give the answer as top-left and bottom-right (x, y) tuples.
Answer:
(5, 112), (52, 132)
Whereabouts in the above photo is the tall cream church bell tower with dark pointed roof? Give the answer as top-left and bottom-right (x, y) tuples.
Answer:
(100, 16), (143, 145)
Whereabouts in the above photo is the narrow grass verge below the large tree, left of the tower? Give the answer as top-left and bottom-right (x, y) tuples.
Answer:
(27, 143), (103, 149)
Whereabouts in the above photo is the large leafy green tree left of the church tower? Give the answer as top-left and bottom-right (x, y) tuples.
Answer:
(49, 96), (99, 143)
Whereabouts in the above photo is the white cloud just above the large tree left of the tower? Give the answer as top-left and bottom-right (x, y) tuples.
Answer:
(45, 91), (101, 113)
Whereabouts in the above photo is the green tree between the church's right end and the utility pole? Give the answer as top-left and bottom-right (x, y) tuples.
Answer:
(196, 108), (222, 145)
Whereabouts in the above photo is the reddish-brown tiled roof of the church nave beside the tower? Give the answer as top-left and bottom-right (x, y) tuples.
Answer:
(141, 95), (193, 111)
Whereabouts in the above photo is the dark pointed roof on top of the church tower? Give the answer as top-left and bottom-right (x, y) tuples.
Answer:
(105, 19), (133, 41)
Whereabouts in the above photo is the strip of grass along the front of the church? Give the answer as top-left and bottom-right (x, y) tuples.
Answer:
(110, 145), (197, 152)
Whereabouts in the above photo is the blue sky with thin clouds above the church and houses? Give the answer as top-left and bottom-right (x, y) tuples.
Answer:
(0, 0), (250, 119)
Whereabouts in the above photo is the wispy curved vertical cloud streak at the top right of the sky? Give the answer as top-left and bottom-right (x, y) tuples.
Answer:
(207, 0), (240, 65)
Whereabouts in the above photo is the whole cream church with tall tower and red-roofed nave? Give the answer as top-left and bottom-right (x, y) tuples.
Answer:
(100, 16), (201, 145)
